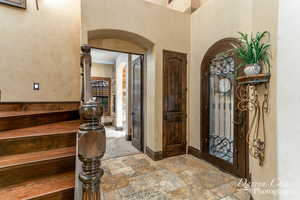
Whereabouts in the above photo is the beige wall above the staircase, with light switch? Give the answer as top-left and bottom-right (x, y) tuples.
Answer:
(0, 0), (80, 101)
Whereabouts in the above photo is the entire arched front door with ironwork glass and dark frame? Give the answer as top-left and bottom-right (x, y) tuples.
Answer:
(201, 38), (248, 177)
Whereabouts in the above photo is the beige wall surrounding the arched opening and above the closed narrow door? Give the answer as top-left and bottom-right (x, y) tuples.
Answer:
(82, 0), (190, 151)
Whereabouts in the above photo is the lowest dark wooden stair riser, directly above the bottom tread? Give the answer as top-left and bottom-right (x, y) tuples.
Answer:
(0, 156), (75, 187)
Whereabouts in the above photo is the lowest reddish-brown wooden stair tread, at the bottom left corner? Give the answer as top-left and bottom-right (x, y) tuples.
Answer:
(0, 171), (75, 200)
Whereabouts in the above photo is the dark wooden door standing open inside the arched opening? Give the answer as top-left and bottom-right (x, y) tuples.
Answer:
(132, 56), (144, 151)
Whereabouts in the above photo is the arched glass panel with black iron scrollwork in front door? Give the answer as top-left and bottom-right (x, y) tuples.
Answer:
(208, 54), (234, 163)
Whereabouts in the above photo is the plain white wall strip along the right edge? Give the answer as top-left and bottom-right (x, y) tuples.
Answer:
(274, 0), (300, 200)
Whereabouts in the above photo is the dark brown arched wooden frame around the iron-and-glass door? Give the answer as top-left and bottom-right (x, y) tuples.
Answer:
(200, 38), (249, 178)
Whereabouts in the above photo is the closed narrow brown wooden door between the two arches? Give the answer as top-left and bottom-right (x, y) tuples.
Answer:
(163, 51), (187, 157)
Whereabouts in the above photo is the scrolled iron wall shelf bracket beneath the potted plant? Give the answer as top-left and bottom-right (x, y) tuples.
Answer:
(236, 73), (271, 166)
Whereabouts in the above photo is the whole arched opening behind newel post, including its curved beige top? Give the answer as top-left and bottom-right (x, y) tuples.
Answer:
(88, 30), (152, 159)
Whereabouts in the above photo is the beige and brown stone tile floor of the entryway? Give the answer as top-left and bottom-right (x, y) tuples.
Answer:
(101, 154), (249, 200)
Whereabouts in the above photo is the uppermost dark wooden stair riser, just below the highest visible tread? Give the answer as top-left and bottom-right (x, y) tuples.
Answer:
(0, 110), (79, 131)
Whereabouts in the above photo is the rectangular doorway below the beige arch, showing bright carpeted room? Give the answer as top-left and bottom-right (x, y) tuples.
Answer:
(91, 48), (144, 159)
